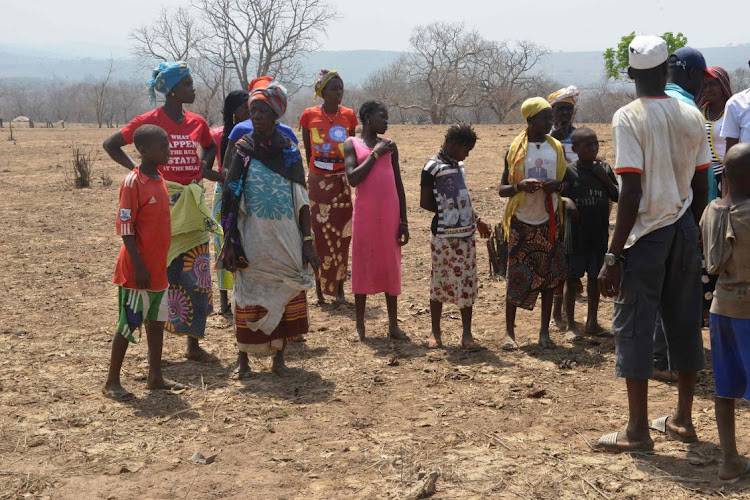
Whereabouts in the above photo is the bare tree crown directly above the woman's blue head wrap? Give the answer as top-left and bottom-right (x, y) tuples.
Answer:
(130, 7), (207, 62)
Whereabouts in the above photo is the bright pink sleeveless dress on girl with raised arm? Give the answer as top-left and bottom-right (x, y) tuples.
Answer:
(352, 137), (401, 295)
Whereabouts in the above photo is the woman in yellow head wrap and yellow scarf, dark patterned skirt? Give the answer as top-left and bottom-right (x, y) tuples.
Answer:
(499, 97), (567, 350)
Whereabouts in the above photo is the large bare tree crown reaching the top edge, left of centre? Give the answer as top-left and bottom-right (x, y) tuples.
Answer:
(192, 0), (336, 88)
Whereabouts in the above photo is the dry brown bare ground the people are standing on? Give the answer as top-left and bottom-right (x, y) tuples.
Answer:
(0, 122), (750, 499)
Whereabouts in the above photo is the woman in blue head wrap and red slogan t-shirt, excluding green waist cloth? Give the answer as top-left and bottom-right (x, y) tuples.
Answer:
(104, 61), (223, 360)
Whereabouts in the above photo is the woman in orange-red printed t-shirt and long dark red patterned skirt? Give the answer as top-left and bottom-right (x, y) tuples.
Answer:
(299, 69), (359, 304)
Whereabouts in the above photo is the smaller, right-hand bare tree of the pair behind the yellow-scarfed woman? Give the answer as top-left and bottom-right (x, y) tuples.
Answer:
(478, 41), (546, 123)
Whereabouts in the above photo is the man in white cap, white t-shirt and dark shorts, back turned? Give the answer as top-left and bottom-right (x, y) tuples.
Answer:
(598, 36), (711, 452)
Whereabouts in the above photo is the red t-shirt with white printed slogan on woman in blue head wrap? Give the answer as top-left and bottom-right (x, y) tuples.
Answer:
(120, 108), (214, 185)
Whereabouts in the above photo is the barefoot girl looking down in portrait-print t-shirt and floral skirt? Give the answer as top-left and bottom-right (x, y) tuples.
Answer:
(419, 123), (490, 350)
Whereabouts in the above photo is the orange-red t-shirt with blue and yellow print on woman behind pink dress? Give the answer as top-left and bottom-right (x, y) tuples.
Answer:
(299, 106), (359, 175)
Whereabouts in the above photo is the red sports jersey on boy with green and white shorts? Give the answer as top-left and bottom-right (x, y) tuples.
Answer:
(112, 167), (172, 292)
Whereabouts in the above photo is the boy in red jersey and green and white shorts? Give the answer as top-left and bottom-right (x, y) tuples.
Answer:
(102, 125), (188, 401)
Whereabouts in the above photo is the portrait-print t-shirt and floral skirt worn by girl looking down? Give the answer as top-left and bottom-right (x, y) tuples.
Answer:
(420, 156), (477, 309)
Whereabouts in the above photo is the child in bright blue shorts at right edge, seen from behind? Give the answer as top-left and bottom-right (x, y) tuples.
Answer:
(701, 144), (750, 483)
